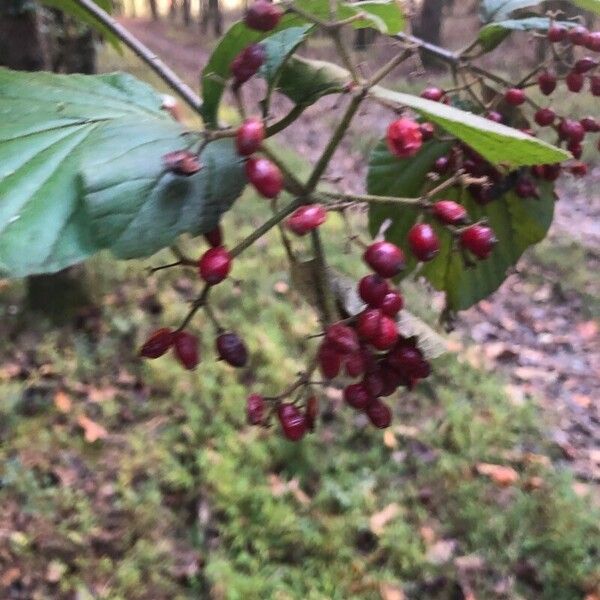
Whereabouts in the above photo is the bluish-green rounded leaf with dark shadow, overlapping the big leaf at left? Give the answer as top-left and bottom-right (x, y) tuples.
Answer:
(82, 138), (246, 259)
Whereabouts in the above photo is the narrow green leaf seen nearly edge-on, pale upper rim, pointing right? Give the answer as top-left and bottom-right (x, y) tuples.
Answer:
(370, 86), (570, 167)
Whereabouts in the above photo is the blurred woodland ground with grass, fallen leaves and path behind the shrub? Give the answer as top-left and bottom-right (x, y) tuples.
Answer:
(0, 0), (600, 600)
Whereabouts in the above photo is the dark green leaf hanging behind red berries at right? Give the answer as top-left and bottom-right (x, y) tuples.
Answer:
(368, 143), (554, 310)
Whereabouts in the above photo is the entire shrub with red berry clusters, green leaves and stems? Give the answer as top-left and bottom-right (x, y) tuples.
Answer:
(0, 0), (600, 441)
